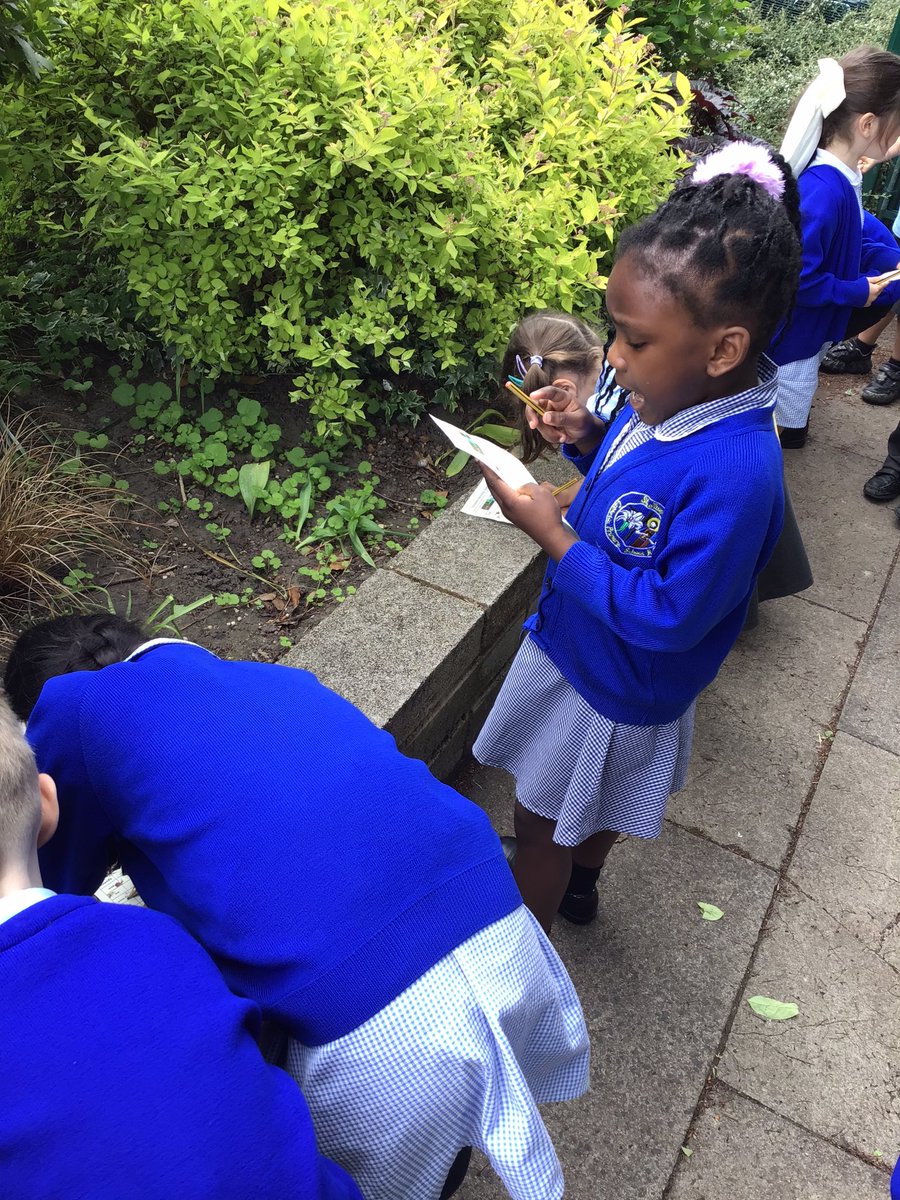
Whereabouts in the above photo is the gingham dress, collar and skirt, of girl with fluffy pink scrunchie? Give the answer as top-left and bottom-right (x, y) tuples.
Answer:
(474, 356), (778, 846)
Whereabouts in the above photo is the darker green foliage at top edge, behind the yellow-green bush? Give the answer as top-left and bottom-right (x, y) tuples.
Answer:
(601, 0), (751, 77)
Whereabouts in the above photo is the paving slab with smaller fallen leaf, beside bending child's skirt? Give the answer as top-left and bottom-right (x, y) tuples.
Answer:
(460, 770), (775, 1200)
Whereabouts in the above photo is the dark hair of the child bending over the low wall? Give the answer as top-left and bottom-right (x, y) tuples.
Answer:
(4, 612), (146, 721)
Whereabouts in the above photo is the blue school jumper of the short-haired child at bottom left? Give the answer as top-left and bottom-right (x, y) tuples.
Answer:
(0, 895), (361, 1200)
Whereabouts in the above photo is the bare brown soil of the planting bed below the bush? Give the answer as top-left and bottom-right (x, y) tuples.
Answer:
(0, 377), (484, 661)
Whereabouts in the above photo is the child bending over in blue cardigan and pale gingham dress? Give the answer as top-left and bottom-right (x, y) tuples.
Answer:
(6, 614), (588, 1200)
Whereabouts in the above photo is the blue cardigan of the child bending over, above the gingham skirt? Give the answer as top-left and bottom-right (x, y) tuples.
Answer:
(28, 644), (522, 1045)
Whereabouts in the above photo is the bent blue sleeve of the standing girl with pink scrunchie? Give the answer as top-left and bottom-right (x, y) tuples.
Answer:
(553, 453), (784, 653)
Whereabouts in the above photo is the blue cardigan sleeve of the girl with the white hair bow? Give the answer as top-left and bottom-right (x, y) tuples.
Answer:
(797, 173), (869, 308)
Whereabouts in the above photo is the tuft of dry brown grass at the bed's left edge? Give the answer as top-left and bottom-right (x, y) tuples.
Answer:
(0, 413), (130, 608)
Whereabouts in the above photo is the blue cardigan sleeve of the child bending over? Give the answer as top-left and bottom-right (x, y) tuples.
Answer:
(25, 671), (115, 895)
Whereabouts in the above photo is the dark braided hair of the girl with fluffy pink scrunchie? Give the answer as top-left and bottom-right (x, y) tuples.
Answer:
(616, 148), (800, 353)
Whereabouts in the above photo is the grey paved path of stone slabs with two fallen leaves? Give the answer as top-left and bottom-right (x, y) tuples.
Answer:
(458, 350), (900, 1200)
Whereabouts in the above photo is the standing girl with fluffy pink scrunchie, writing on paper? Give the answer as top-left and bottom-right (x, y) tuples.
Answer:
(475, 144), (800, 929)
